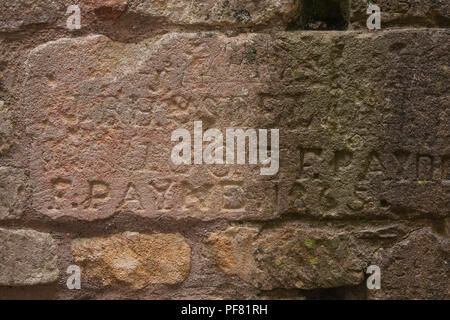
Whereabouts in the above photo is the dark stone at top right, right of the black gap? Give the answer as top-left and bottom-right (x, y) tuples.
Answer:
(350, 0), (450, 29)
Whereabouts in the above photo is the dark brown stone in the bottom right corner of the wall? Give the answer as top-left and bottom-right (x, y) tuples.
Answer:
(367, 229), (450, 300)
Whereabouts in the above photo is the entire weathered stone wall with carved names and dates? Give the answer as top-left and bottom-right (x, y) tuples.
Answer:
(0, 0), (450, 299)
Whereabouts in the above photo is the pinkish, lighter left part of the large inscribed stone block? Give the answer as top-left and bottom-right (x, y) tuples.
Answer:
(25, 34), (276, 220)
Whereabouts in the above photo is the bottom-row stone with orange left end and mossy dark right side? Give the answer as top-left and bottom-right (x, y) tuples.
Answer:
(205, 225), (364, 290)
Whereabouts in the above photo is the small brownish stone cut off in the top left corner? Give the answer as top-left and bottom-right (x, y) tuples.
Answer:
(0, 0), (72, 32)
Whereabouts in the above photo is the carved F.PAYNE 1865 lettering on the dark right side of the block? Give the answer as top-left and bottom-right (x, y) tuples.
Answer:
(282, 147), (450, 216)
